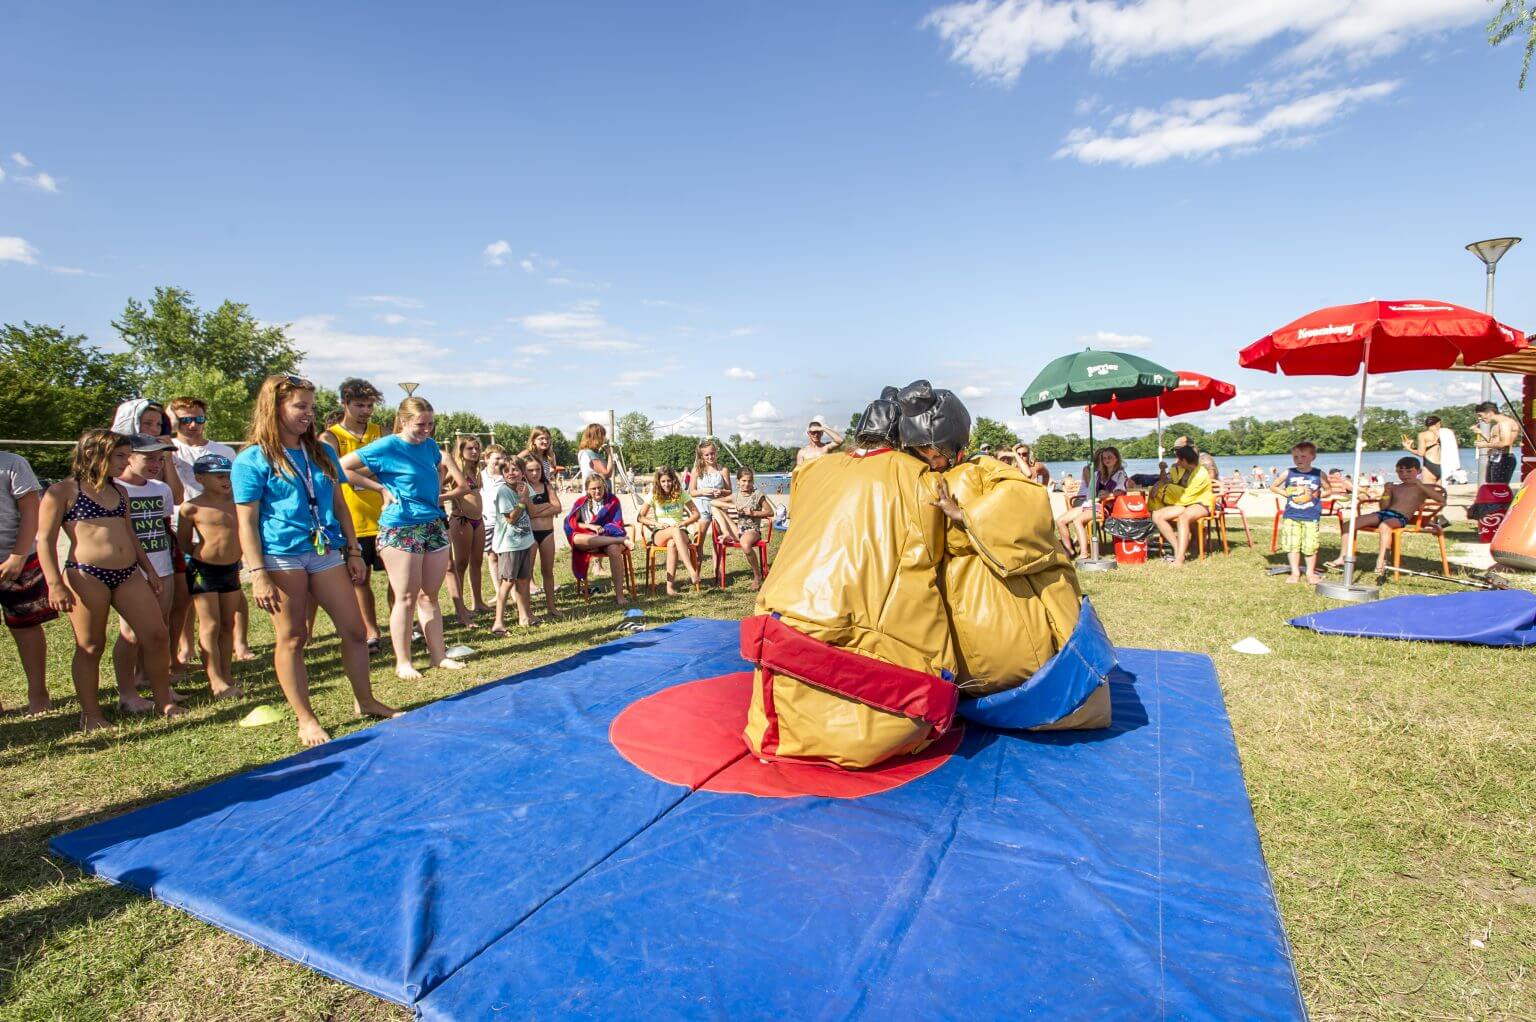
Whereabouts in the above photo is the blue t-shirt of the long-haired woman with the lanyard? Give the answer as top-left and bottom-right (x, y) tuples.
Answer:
(229, 444), (346, 556)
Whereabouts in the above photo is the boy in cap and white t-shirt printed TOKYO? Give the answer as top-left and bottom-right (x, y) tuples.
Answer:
(112, 433), (186, 713)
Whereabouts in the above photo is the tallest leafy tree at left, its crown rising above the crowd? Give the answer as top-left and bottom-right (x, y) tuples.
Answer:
(112, 287), (301, 410)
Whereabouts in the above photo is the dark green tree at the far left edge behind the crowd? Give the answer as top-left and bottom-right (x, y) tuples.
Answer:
(0, 323), (134, 478)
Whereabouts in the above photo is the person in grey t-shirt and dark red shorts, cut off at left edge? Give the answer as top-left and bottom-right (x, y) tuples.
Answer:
(0, 450), (58, 713)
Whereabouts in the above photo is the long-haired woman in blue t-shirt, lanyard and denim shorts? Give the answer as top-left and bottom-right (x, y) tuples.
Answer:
(230, 377), (399, 745)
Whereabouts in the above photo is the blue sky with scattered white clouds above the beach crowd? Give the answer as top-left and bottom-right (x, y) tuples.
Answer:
(0, 0), (1536, 441)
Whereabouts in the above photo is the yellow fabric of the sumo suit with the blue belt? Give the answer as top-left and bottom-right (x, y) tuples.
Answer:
(943, 456), (1109, 730)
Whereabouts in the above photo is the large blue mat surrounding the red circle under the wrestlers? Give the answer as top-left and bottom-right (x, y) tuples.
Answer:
(52, 619), (1304, 1020)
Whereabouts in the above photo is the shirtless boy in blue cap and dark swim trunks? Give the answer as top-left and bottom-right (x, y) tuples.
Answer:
(177, 455), (246, 699)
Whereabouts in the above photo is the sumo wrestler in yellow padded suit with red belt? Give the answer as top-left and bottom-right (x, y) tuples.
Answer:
(742, 381), (971, 768)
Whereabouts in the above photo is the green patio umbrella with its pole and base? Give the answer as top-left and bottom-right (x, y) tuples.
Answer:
(1020, 347), (1178, 570)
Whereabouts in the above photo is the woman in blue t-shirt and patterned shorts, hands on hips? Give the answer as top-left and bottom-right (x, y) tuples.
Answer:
(341, 398), (470, 681)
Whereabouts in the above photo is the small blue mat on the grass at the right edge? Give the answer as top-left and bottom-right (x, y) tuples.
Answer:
(1290, 589), (1536, 645)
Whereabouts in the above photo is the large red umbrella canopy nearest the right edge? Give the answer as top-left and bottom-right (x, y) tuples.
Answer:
(1238, 298), (1525, 377)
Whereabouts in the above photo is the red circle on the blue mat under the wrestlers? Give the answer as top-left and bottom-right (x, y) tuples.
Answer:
(608, 672), (965, 799)
